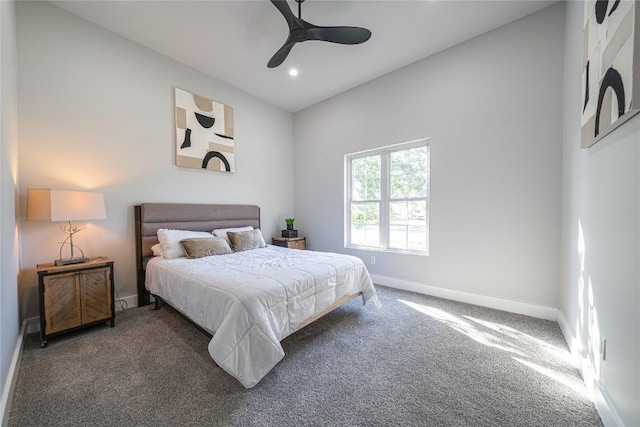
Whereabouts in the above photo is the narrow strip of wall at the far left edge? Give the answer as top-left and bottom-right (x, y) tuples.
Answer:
(0, 1), (20, 421)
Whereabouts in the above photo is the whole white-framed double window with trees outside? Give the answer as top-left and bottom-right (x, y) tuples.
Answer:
(345, 139), (429, 254)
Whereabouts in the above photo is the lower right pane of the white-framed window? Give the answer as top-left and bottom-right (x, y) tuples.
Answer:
(389, 200), (428, 251)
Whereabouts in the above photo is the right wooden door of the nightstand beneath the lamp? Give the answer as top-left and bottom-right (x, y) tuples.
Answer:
(78, 267), (111, 323)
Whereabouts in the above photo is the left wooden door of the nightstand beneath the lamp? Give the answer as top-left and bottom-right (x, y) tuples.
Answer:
(44, 273), (82, 334)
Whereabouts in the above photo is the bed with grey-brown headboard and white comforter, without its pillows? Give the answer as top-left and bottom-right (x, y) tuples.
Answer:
(135, 203), (379, 388)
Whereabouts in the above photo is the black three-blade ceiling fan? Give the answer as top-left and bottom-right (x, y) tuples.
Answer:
(267, 0), (371, 68)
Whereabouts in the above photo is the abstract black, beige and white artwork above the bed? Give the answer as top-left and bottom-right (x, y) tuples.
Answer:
(175, 88), (235, 172)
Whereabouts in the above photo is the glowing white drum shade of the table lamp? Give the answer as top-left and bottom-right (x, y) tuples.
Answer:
(27, 188), (107, 221)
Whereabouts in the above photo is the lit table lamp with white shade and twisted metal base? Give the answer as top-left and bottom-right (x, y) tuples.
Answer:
(27, 188), (107, 266)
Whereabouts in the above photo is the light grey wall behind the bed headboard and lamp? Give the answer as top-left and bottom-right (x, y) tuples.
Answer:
(17, 2), (293, 317)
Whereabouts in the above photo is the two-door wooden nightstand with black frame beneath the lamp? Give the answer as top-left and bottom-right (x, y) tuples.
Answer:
(37, 257), (115, 347)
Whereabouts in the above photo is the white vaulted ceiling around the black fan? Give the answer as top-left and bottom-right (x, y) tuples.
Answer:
(51, 0), (555, 112)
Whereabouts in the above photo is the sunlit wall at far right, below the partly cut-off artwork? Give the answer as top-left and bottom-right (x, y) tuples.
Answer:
(560, 2), (640, 426)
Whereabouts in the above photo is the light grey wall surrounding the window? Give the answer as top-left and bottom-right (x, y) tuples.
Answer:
(294, 4), (564, 316)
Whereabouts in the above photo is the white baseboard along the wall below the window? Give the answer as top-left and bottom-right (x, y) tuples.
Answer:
(371, 274), (558, 320)
